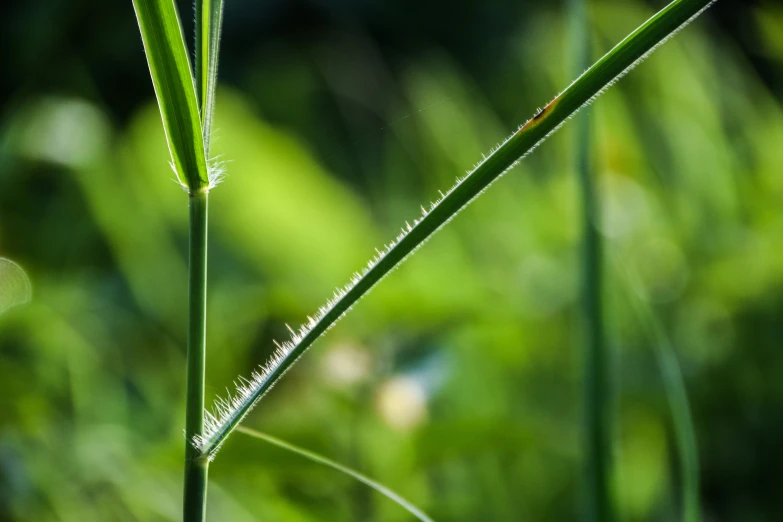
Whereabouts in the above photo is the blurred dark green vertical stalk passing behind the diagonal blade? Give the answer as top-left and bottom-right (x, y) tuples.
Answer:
(568, 0), (615, 522)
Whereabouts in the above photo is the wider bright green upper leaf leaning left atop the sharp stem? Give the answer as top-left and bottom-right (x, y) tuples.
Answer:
(133, 0), (210, 193)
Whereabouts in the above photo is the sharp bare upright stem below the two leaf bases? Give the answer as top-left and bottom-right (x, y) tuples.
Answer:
(183, 190), (209, 522)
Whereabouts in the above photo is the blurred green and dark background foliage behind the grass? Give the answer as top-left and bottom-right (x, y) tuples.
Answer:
(0, 0), (783, 522)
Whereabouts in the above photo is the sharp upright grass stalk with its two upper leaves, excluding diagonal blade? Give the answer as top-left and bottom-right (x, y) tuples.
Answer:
(133, 0), (223, 522)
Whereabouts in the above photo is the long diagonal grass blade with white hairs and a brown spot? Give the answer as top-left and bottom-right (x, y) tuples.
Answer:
(193, 0), (712, 458)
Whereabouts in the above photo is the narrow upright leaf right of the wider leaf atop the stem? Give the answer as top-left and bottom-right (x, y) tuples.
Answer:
(195, 0), (223, 157)
